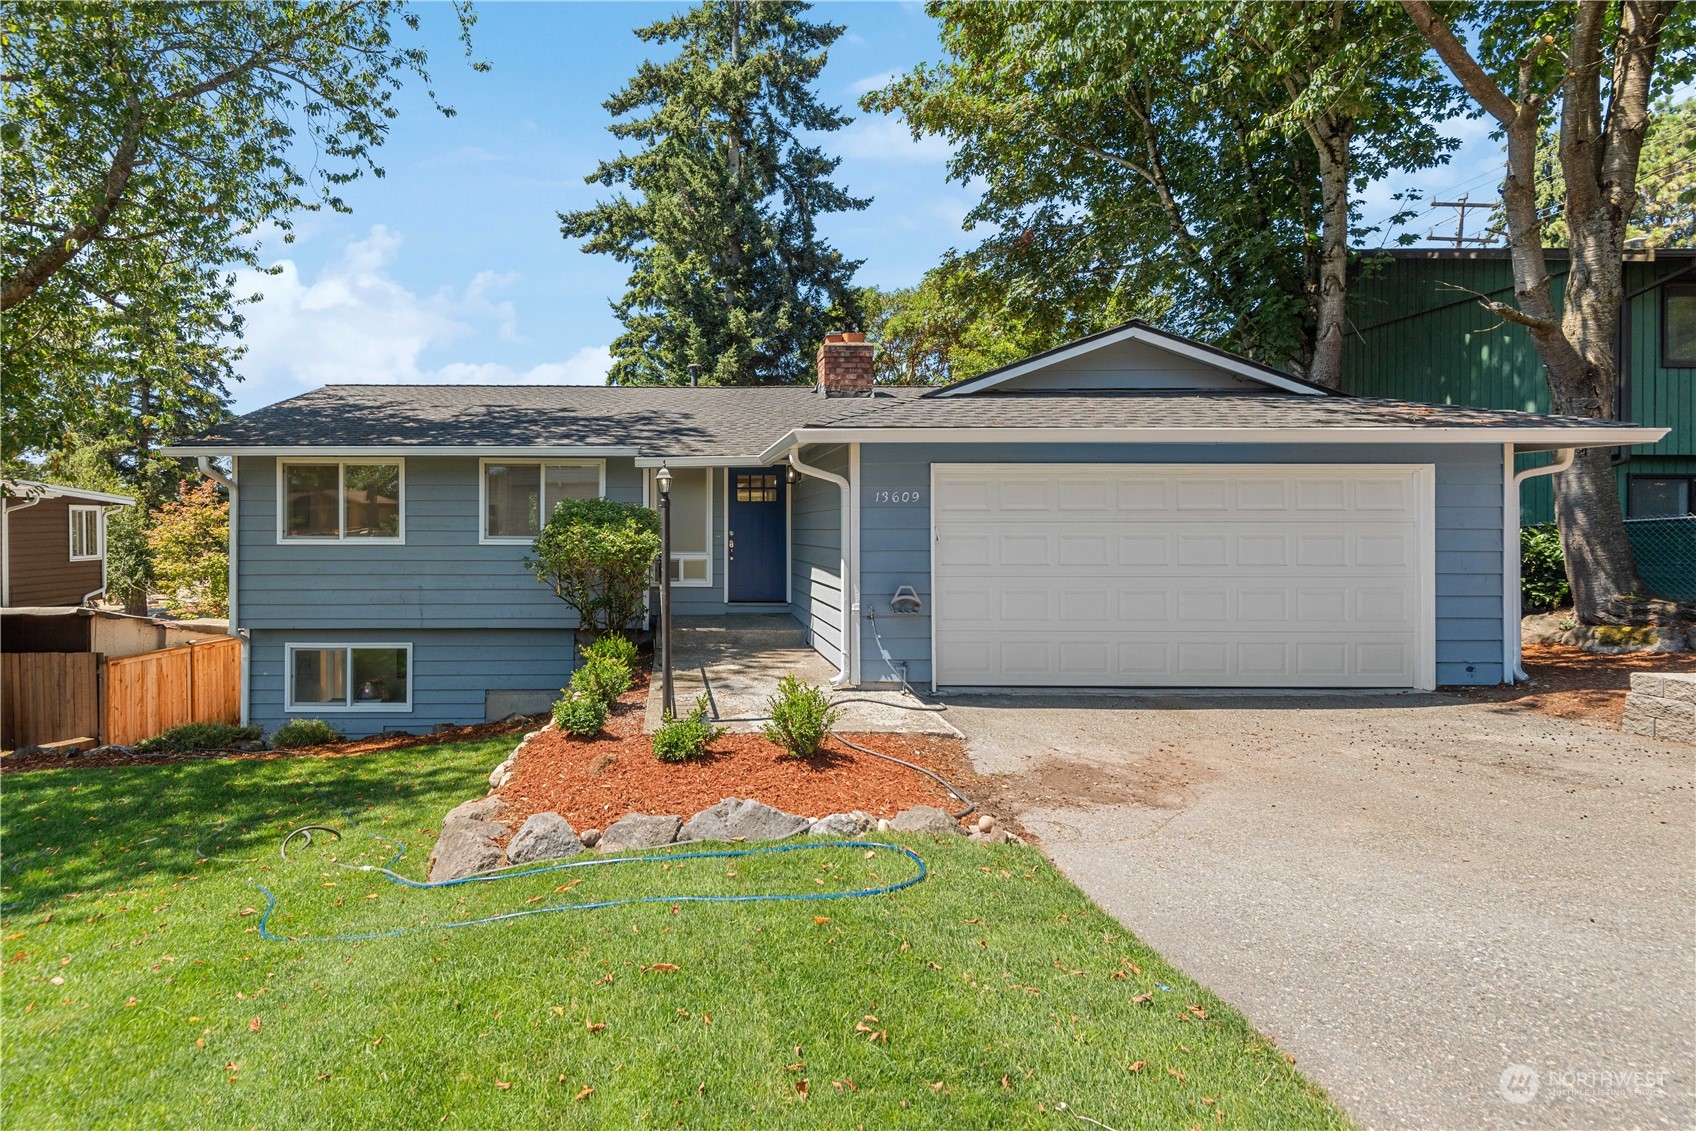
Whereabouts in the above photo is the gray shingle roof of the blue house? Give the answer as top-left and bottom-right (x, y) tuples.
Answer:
(183, 385), (1648, 458)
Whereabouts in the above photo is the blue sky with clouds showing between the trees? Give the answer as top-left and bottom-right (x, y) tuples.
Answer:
(232, 2), (1501, 412)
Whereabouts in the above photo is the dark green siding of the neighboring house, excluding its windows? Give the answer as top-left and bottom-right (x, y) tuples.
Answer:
(1343, 258), (1696, 524)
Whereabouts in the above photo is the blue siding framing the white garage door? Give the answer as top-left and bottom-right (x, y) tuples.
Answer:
(858, 444), (1518, 685)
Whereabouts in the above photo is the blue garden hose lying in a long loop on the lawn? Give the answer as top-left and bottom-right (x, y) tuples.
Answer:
(253, 838), (929, 943)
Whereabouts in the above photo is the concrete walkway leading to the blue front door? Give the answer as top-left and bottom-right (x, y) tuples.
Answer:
(643, 614), (958, 734)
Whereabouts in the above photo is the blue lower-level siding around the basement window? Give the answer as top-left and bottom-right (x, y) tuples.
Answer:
(248, 627), (575, 736)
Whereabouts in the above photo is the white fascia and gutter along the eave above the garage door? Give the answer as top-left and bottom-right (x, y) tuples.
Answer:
(760, 427), (1671, 463)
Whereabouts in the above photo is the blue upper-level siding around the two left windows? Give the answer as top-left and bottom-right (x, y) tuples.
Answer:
(237, 456), (641, 629)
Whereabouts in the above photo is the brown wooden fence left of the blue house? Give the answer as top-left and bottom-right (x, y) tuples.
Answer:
(0, 636), (241, 749)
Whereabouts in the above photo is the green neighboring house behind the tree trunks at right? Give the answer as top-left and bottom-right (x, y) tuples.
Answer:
(1343, 248), (1696, 526)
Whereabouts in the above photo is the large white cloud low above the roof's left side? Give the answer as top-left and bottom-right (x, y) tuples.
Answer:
(232, 224), (611, 412)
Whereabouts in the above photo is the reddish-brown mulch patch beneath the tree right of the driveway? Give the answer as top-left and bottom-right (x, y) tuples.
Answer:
(1443, 644), (1696, 731)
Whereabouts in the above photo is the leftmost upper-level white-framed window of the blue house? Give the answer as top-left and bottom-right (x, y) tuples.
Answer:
(276, 460), (405, 543)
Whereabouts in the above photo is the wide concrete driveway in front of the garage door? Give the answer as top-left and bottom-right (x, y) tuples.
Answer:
(945, 695), (1696, 1128)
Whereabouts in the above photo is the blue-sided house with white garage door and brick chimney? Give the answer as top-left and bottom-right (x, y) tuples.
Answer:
(170, 322), (1664, 734)
